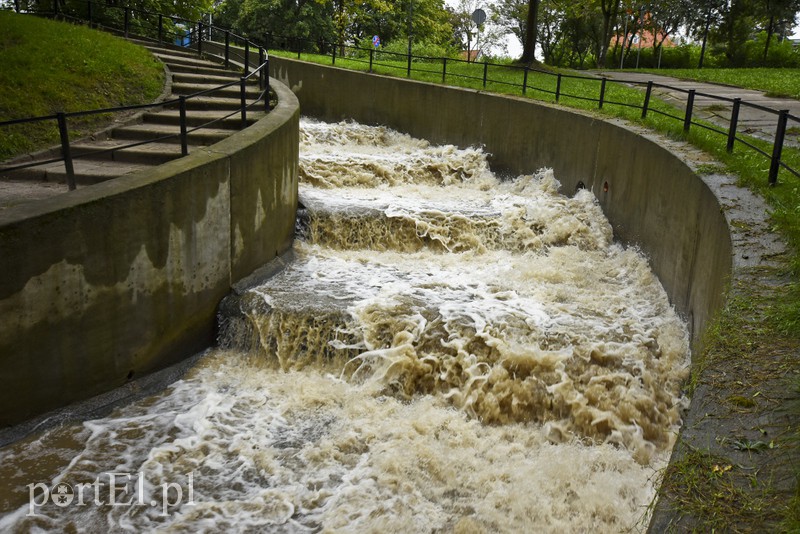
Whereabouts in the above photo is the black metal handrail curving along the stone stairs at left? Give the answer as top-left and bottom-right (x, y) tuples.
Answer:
(0, 0), (270, 190)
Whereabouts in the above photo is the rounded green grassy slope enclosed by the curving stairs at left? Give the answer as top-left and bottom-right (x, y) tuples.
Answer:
(0, 11), (164, 160)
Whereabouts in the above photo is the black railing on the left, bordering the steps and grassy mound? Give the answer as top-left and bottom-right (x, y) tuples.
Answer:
(0, 0), (270, 190)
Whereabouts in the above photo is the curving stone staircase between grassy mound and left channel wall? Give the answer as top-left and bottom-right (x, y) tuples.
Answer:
(3, 39), (265, 191)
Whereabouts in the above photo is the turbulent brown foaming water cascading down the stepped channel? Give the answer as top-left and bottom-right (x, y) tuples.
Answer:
(0, 120), (688, 532)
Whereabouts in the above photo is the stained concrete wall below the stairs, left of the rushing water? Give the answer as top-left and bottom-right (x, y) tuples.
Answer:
(0, 80), (299, 427)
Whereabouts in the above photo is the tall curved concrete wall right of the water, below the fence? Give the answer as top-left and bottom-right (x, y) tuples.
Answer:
(270, 56), (732, 348)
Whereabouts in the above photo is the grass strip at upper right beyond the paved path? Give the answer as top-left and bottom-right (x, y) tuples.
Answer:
(637, 69), (800, 99)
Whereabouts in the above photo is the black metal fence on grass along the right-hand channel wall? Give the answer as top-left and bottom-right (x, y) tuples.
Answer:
(267, 34), (800, 185)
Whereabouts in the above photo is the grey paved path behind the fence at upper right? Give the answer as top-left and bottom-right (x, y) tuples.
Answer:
(595, 70), (800, 146)
